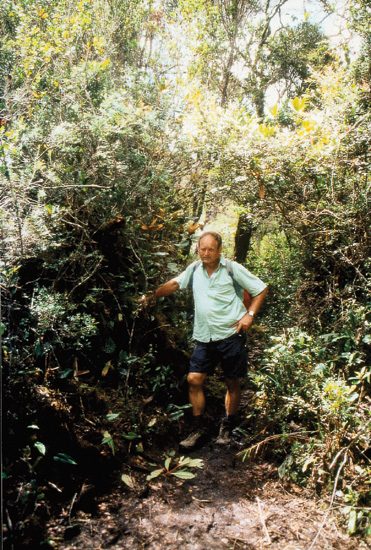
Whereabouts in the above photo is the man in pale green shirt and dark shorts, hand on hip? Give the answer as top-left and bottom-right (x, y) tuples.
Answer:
(144, 231), (267, 449)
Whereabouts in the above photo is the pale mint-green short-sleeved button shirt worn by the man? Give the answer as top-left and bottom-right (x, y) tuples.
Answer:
(175, 256), (266, 342)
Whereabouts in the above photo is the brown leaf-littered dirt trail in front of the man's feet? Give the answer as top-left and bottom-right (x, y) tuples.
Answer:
(49, 443), (369, 550)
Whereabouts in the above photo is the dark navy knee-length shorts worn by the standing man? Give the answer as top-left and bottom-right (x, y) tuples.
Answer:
(189, 334), (247, 378)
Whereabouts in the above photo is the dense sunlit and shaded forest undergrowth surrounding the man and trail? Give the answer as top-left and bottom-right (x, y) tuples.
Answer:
(0, 0), (371, 548)
